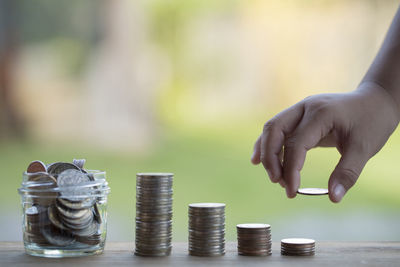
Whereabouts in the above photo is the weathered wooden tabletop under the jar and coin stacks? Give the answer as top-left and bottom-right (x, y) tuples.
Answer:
(0, 242), (400, 267)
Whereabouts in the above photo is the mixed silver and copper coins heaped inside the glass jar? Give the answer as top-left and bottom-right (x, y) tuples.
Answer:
(24, 159), (102, 247)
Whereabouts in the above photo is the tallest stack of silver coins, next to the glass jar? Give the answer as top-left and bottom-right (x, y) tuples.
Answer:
(135, 173), (173, 256)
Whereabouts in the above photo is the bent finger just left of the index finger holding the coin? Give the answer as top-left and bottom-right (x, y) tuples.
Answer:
(260, 102), (304, 186)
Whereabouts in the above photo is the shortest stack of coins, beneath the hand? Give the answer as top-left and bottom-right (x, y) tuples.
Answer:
(281, 238), (315, 256)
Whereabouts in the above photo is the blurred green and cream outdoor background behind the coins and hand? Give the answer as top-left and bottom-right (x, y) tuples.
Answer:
(0, 0), (400, 241)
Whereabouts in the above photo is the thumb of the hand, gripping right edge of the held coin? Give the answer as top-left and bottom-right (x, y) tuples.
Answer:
(328, 148), (368, 203)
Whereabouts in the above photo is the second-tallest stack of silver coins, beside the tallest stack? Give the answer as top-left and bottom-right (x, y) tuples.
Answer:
(189, 203), (225, 256)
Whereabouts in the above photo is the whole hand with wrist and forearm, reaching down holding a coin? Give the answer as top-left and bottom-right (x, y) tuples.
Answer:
(251, 5), (400, 203)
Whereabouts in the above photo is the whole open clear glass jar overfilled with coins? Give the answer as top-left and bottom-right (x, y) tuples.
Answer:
(18, 159), (110, 258)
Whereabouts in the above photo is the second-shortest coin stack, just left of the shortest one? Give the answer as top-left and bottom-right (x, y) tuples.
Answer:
(236, 223), (271, 256)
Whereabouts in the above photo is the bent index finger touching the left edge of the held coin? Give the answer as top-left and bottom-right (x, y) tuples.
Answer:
(283, 117), (330, 198)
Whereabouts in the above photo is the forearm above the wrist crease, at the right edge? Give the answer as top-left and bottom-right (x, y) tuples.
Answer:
(361, 5), (400, 109)
